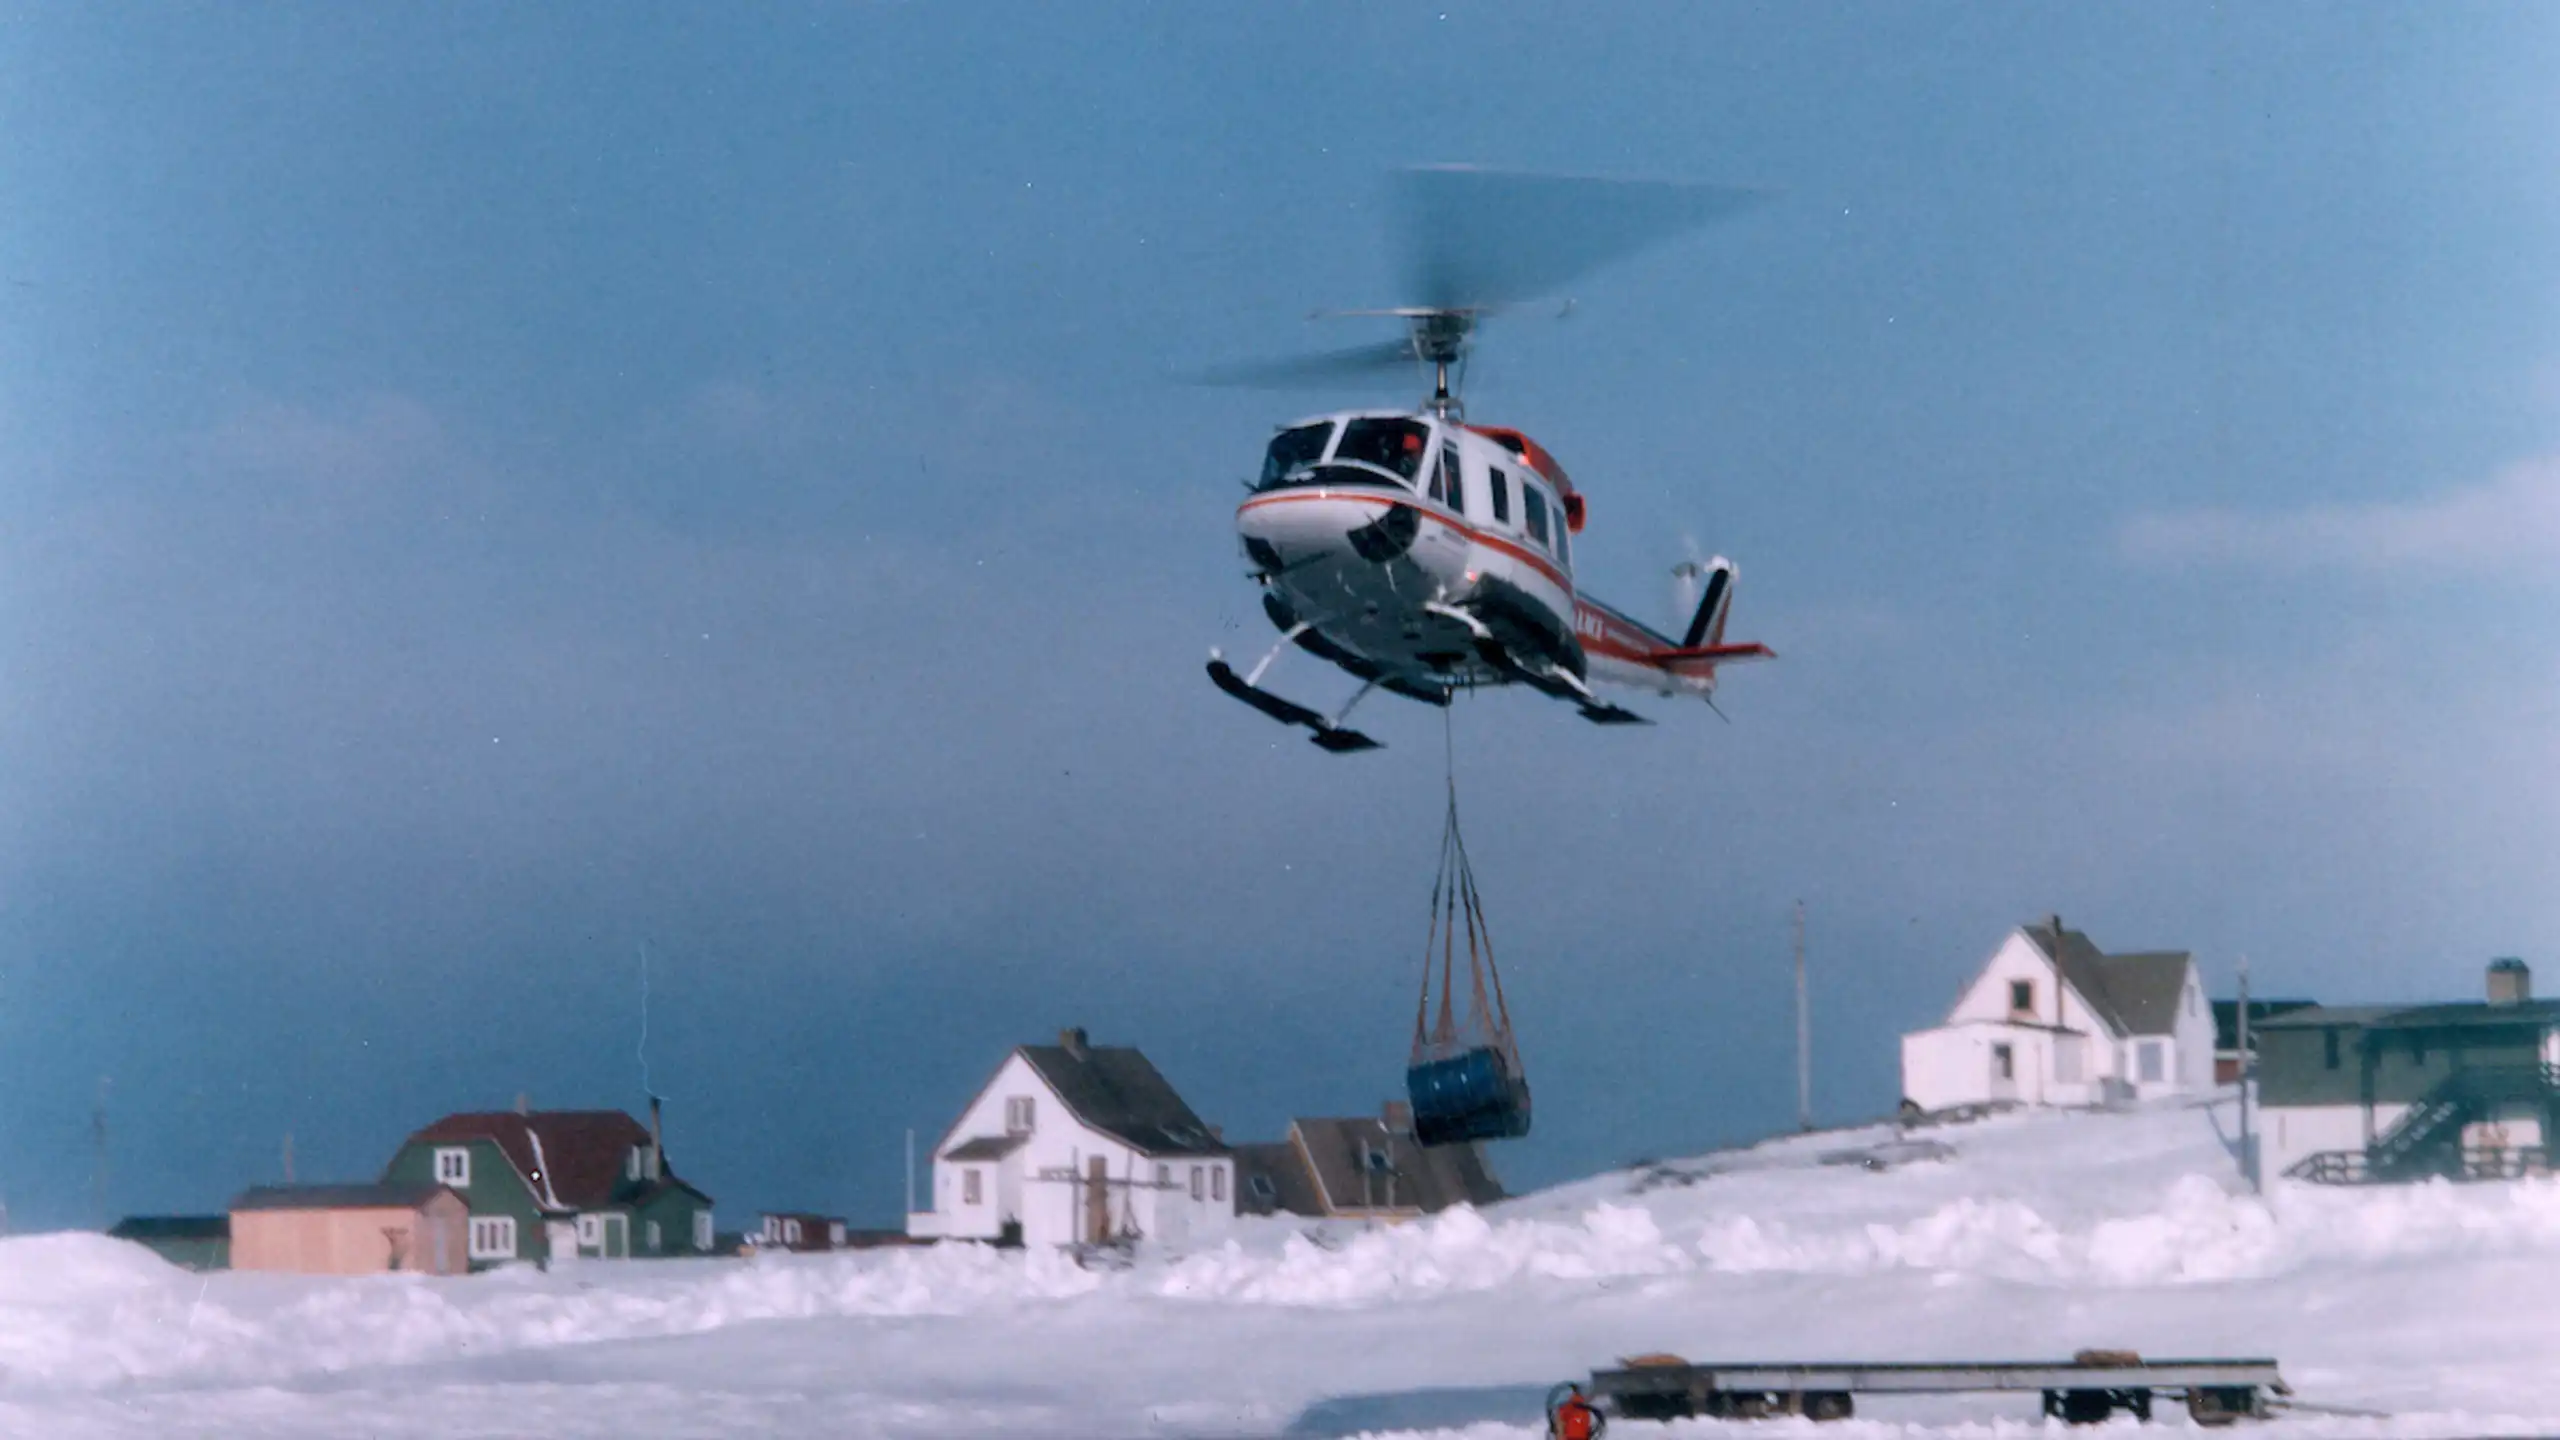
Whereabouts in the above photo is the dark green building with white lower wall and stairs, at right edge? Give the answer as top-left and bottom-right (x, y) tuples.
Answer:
(2255, 958), (2560, 1184)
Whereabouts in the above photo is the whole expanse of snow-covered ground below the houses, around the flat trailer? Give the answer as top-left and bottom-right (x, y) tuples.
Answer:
(0, 1104), (2560, 1440)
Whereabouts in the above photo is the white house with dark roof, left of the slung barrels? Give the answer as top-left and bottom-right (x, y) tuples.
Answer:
(906, 1030), (1236, 1245)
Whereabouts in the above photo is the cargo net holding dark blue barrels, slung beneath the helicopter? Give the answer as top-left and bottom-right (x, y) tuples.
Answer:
(1405, 784), (1528, 1145)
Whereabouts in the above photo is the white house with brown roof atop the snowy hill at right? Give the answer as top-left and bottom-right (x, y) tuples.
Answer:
(1902, 915), (2214, 1109)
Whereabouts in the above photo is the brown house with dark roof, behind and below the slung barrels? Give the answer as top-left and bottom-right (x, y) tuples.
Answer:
(1236, 1102), (1503, 1220)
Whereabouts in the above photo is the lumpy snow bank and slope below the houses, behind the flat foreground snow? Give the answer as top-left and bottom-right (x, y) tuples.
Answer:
(15, 1091), (2560, 1393)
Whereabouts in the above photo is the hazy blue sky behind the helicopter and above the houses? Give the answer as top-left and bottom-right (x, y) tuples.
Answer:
(0, 5), (2560, 1225)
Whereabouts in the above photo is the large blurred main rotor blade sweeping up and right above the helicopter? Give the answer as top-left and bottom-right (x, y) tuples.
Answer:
(1395, 167), (1769, 310)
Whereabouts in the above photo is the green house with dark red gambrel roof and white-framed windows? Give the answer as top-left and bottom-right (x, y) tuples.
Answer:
(381, 1102), (714, 1268)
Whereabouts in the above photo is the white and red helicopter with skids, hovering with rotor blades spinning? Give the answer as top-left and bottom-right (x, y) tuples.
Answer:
(1201, 167), (1774, 753)
